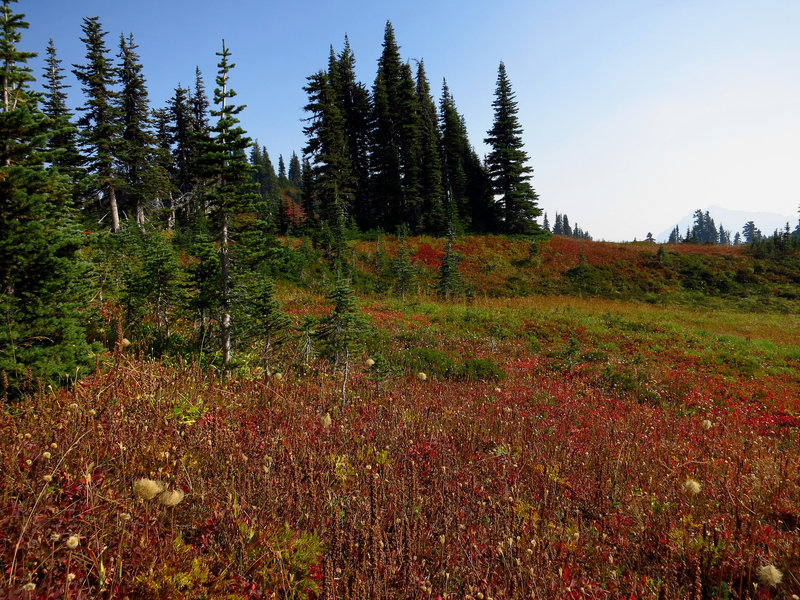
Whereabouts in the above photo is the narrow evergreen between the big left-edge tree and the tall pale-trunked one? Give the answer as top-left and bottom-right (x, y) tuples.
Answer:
(42, 38), (83, 185)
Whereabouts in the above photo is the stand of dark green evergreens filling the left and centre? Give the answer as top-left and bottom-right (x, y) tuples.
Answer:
(0, 0), (552, 396)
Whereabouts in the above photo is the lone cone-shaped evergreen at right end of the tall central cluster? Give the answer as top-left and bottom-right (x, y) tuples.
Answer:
(484, 62), (541, 234)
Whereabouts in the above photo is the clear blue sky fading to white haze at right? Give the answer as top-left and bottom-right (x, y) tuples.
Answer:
(16, 0), (800, 240)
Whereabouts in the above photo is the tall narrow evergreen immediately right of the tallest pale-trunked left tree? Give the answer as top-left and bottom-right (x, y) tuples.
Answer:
(118, 35), (168, 227)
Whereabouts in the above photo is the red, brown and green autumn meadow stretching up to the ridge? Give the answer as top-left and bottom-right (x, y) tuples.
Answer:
(0, 237), (800, 600)
